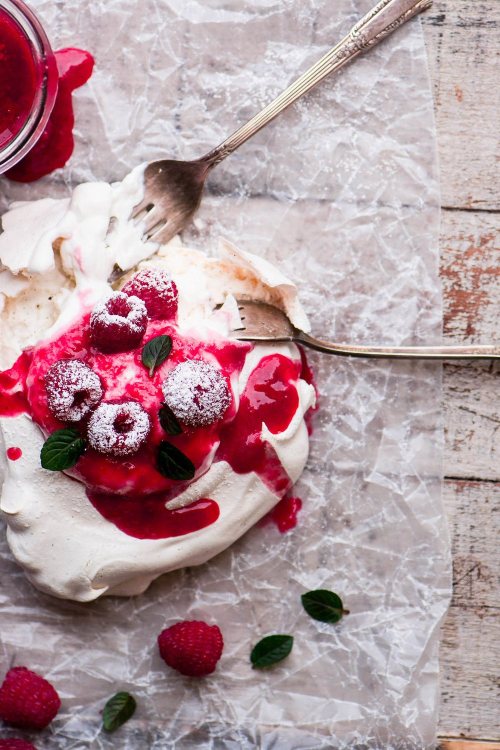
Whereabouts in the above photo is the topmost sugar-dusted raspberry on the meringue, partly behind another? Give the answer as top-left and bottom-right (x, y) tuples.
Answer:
(122, 268), (178, 320)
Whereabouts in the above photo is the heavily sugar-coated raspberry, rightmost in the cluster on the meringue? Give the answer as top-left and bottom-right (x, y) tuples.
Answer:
(162, 359), (231, 427)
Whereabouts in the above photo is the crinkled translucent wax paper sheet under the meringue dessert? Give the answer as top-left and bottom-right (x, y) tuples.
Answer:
(0, 0), (449, 750)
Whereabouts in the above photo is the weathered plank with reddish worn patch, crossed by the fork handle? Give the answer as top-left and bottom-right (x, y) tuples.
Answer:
(440, 211), (500, 480)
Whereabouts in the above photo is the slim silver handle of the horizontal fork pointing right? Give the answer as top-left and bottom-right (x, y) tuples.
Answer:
(294, 331), (500, 360)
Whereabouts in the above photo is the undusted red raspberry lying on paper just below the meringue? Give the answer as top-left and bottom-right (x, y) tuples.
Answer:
(158, 620), (224, 677)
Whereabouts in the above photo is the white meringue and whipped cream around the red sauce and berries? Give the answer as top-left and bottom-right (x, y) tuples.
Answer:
(0, 167), (315, 601)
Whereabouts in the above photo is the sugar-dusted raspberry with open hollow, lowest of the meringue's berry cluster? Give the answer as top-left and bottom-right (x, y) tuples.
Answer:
(87, 401), (151, 457)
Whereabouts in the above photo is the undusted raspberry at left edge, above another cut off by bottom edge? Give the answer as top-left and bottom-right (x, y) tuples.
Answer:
(0, 667), (61, 729)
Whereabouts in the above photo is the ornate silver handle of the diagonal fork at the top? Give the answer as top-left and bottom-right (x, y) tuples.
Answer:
(205, 0), (432, 167)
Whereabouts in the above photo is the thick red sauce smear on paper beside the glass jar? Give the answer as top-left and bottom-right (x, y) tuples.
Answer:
(6, 48), (94, 182)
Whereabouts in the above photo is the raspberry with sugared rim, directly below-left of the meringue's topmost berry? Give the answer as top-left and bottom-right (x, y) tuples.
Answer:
(90, 292), (148, 353)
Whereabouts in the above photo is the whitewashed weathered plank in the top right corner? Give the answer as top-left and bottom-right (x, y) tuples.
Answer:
(422, 0), (500, 209)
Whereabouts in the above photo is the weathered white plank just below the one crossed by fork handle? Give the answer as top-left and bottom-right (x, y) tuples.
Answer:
(439, 480), (500, 740)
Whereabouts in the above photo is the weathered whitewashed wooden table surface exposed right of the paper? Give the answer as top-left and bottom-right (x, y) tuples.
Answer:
(423, 0), (500, 750)
